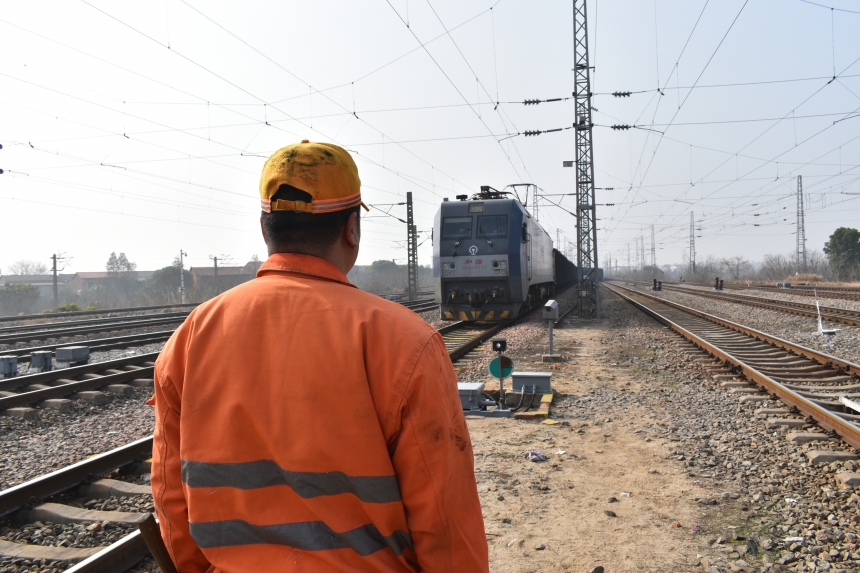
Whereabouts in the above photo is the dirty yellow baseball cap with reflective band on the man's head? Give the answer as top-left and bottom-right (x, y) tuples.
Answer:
(260, 139), (369, 215)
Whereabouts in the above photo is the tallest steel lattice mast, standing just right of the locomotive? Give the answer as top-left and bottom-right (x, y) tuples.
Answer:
(573, 0), (600, 318)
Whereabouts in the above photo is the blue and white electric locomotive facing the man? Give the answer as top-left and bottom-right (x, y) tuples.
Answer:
(433, 186), (576, 321)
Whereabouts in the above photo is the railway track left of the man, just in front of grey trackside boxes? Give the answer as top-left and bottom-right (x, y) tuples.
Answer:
(0, 352), (158, 418)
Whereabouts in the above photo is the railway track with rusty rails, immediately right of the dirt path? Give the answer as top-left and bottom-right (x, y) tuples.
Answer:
(603, 283), (860, 448)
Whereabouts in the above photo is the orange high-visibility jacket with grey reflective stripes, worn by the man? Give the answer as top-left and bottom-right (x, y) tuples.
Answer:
(152, 254), (489, 573)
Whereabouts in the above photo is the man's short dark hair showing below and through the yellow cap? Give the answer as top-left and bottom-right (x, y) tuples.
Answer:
(260, 185), (361, 256)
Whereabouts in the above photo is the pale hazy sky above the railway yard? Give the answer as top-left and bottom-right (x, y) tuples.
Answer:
(0, 0), (860, 272)
